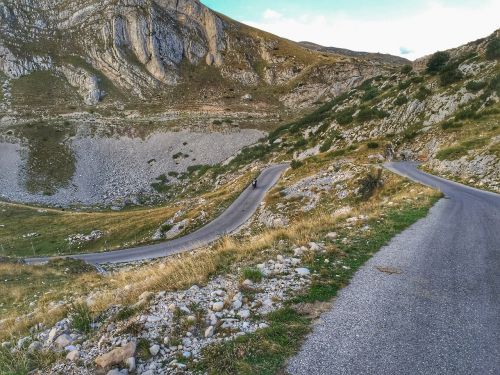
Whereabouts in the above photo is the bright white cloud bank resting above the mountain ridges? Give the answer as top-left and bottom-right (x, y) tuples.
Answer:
(245, 0), (500, 59)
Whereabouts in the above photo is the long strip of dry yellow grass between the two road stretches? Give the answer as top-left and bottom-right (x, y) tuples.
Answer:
(0, 169), (436, 338)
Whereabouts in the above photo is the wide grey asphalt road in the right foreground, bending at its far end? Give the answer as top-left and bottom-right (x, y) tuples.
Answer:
(287, 163), (500, 375)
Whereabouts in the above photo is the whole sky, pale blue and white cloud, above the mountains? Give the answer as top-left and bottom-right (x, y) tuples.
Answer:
(201, 0), (500, 60)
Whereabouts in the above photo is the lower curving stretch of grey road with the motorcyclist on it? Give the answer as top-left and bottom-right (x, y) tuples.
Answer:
(25, 164), (288, 265)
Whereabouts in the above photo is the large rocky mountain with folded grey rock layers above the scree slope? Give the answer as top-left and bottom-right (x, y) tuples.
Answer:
(0, 0), (399, 114)
